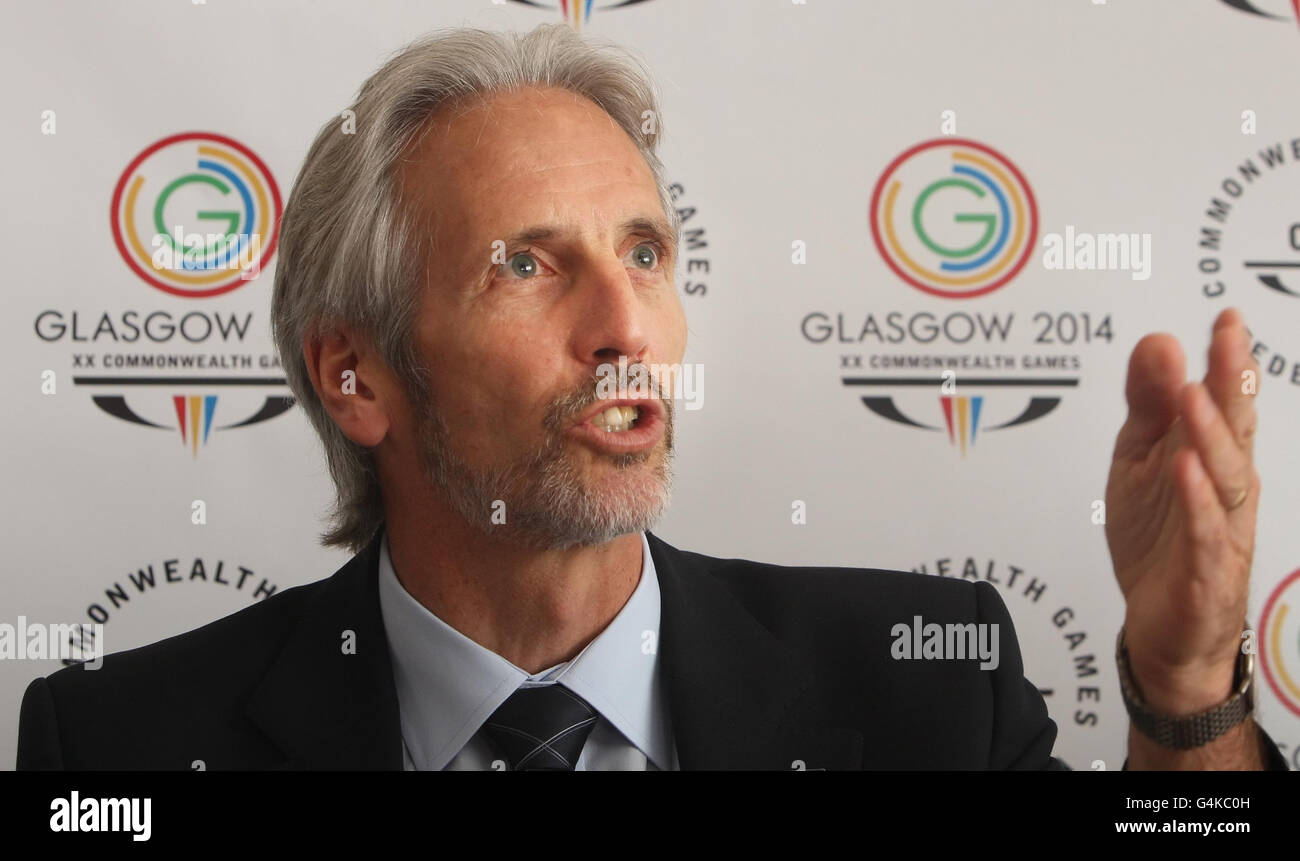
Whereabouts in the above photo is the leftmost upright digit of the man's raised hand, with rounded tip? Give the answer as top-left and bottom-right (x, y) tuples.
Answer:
(1115, 333), (1187, 463)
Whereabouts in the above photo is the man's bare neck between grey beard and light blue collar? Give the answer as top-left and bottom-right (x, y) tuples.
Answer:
(386, 503), (642, 674)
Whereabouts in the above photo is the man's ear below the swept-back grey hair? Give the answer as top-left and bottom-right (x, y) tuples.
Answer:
(303, 328), (397, 449)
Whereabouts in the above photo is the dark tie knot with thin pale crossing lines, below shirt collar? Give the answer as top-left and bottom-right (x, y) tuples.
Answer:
(484, 682), (597, 771)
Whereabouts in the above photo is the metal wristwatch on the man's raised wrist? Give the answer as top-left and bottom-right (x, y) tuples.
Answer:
(1115, 623), (1255, 750)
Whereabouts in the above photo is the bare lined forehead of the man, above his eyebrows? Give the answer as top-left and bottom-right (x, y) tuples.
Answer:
(400, 87), (659, 242)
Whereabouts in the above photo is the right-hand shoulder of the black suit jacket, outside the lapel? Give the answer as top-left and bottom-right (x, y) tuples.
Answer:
(655, 541), (1061, 769)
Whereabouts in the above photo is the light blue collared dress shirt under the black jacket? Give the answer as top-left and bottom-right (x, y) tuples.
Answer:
(378, 532), (679, 771)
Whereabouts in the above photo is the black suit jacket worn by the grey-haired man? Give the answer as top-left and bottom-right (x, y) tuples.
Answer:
(17, 533), (1286, 770)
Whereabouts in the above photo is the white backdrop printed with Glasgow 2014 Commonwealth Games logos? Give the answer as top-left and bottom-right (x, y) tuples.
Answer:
(0, 0), (1300, 769)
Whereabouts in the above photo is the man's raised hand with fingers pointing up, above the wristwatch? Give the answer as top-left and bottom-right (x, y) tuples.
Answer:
(1106, 311), (1258, 707)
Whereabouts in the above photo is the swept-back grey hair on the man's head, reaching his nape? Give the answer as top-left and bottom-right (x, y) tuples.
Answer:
(270, 23), (681, 553)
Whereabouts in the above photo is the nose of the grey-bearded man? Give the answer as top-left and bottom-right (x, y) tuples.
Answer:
(573, 260), (650, 372)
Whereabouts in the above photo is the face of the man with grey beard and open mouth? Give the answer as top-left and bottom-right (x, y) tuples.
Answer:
(400, 88), (686, 548)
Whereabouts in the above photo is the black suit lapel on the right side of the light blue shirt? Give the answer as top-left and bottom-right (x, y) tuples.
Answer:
(647, 533), (862, 770)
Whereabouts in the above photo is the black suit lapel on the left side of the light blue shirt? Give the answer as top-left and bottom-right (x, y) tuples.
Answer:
(246, 531), (402, 770)
